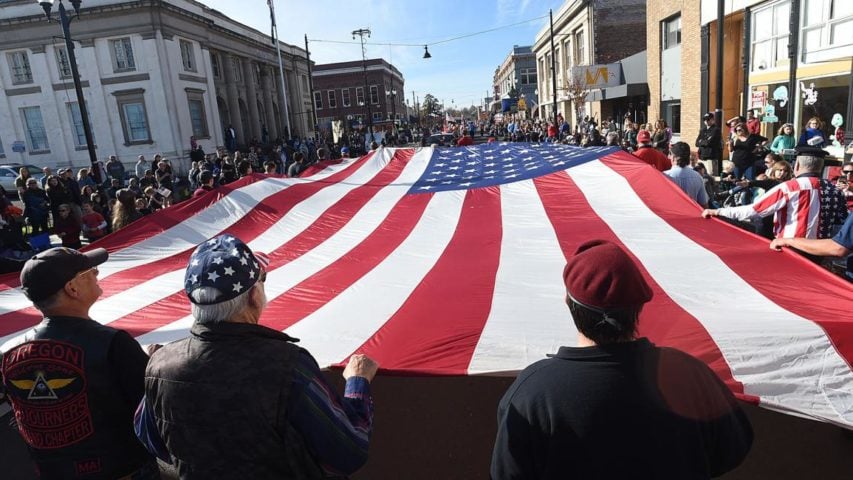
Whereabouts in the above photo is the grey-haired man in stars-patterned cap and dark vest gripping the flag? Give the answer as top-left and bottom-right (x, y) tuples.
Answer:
(134, 234), (378, 479)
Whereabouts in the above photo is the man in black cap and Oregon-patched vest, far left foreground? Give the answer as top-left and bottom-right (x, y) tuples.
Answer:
(0, 248), (160, 480)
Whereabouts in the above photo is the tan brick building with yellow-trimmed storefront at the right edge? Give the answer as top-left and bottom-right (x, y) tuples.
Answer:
(647, 0), (853, 165)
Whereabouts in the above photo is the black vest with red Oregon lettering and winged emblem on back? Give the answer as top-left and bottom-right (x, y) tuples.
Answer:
(0, 317), (151, 479)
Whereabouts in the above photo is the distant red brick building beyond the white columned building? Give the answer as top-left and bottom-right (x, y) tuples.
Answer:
(311, 58), (408, 140)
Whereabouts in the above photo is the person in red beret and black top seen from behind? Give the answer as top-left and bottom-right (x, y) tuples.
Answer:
(491, 240), (752, 480)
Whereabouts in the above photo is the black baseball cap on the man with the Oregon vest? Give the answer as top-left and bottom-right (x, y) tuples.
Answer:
(21, 247), (109, 302)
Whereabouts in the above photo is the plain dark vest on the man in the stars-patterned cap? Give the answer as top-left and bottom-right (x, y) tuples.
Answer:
(145, 322), (325, 480)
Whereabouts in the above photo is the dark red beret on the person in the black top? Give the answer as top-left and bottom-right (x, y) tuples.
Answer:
(563, 240), (652, 310)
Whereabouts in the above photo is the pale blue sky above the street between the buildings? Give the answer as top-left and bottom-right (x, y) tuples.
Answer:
(201, 0), (563, 106)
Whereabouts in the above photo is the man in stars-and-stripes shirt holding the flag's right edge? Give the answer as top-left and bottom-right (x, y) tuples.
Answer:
(702, 146), (847, 238)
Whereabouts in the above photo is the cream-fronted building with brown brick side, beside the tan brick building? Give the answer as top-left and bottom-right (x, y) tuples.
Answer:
(533, 0), (646, 125)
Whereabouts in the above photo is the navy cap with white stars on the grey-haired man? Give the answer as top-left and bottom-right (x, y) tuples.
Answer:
(184, 233), (269, 305)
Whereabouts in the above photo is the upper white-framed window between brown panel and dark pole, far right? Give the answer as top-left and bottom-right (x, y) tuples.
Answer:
(751, 2), (791, 71)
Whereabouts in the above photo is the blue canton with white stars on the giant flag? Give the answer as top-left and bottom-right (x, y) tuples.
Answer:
(410, 143), (619, 193)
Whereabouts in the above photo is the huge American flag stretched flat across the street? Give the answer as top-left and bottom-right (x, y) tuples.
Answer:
(0, 144), (853, 428)
